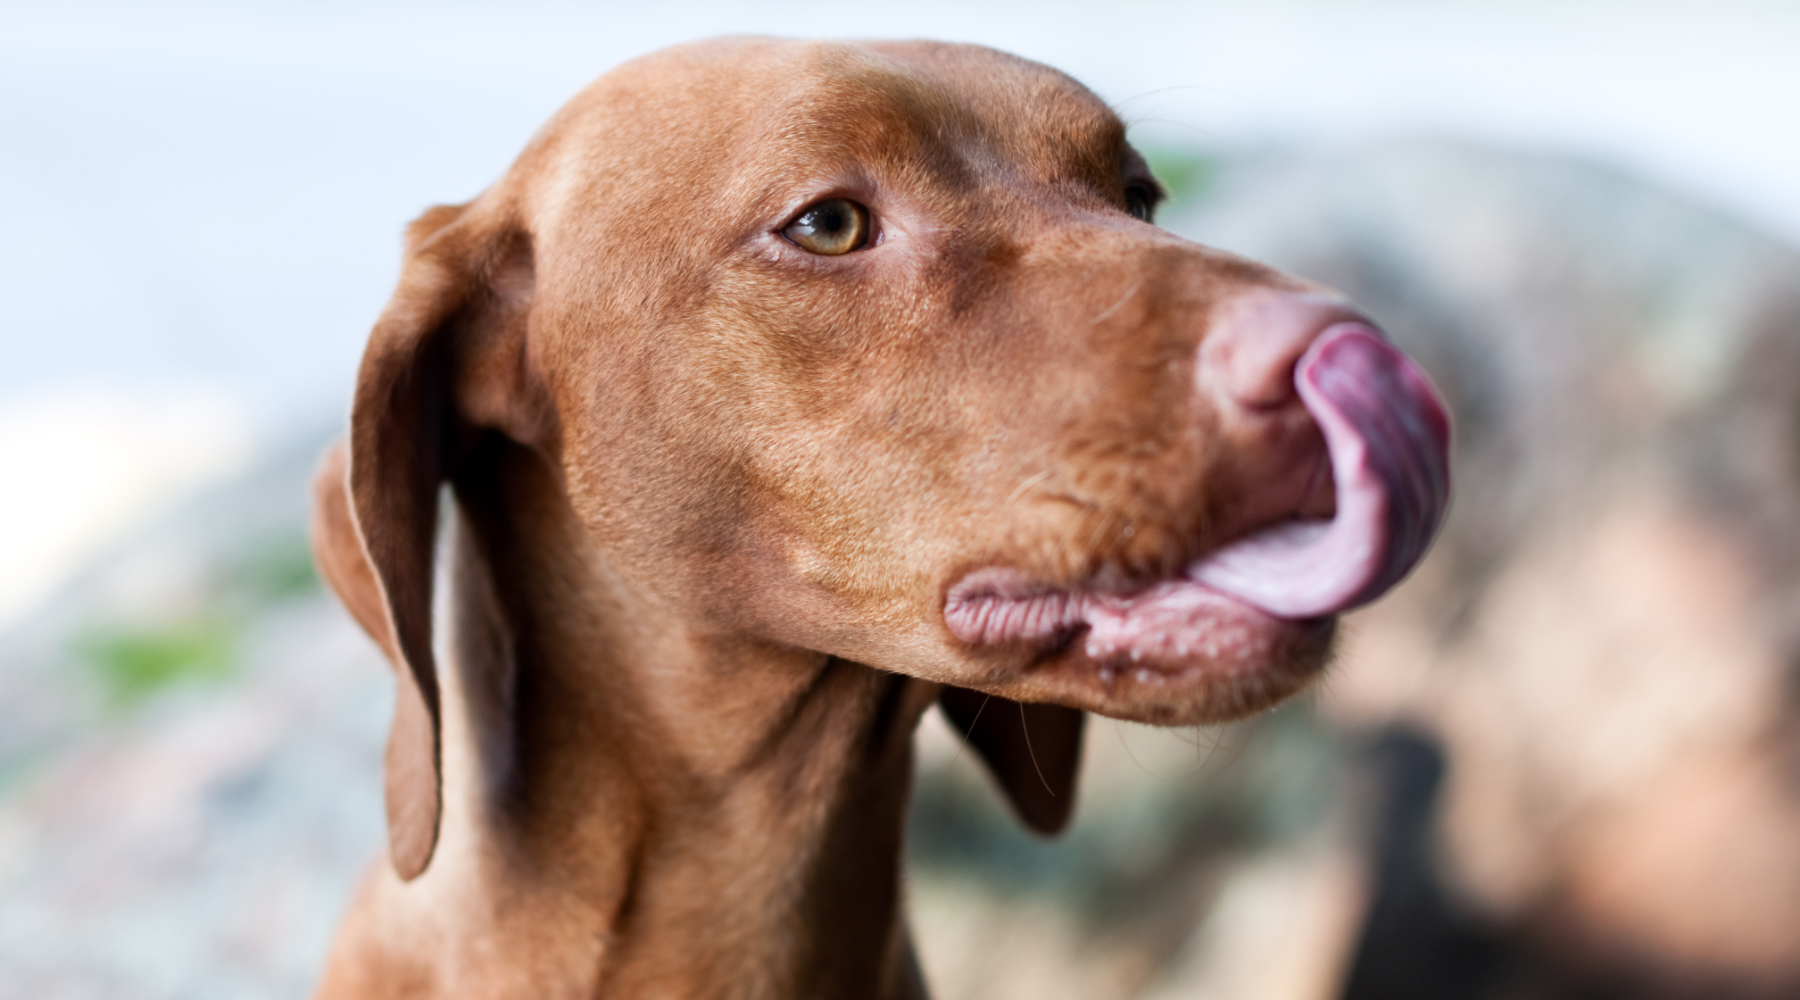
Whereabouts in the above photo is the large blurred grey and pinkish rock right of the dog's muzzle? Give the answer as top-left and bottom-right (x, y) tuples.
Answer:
(1170, 140), (1800, 998)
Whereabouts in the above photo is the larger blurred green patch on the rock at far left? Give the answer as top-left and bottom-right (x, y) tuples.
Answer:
(74, 617), (239, 709)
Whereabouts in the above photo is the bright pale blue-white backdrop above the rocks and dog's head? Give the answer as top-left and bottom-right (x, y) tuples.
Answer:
(0, 0), (1800, 626)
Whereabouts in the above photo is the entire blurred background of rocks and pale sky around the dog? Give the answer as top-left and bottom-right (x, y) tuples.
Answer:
(0, 0), (1800, 1000)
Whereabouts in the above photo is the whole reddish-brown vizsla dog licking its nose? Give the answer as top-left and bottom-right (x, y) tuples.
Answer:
(315, 40), (1449, 1000)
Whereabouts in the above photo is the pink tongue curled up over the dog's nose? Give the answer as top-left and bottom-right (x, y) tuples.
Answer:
(1186, 322), (1451, 619)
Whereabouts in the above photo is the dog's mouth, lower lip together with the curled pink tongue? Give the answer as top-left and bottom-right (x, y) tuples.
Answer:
(943, 322), (1451, 708)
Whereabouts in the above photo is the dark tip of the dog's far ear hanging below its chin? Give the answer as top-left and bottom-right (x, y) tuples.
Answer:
(938, 687), (1087, 835)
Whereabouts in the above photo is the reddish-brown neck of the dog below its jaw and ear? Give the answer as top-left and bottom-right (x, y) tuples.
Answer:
(326, 446), (934, 1000)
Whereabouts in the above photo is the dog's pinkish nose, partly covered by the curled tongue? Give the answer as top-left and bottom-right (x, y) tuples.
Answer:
(1201, 290), (1372, 412)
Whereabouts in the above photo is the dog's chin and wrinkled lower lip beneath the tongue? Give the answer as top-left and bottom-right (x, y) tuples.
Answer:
(945, 570), (1337, 725)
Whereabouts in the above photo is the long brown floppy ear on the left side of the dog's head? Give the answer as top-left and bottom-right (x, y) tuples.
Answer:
(313, 199), (531, 879)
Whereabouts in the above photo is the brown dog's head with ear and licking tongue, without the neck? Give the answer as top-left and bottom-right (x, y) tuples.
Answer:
(320, 40), (1449, 872)
